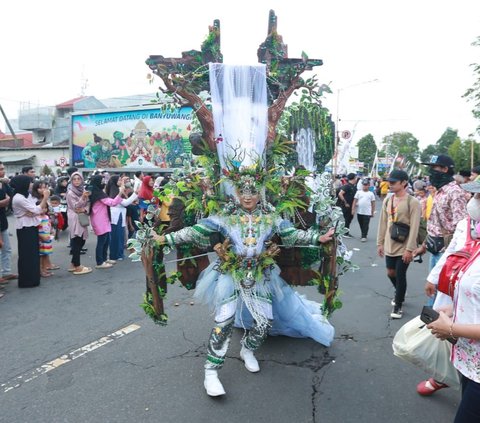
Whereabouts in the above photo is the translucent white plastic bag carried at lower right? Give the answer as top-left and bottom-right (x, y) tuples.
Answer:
(392, 316), (460, 389)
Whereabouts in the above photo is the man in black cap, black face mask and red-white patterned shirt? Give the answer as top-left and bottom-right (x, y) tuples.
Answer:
(415, 154), (467, 278)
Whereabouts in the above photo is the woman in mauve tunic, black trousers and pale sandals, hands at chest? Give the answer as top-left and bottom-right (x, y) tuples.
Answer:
(67, 172), (92, 275)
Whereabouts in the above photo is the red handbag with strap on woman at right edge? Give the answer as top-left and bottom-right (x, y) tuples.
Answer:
(438, 218), (480, 298)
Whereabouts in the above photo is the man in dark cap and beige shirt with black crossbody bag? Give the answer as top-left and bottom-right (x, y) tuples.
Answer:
(377, 170), (420, 319)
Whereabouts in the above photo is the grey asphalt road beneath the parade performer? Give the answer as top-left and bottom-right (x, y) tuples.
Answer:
(0, 210), (460, 423)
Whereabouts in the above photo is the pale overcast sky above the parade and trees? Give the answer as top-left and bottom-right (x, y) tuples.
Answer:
(0, 0), (480, 147)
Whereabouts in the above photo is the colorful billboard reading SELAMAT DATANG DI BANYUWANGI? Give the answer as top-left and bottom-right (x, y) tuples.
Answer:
(71, 107), (193, 169)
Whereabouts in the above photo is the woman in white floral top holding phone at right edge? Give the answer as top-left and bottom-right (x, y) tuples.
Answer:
(417, 189), (480, 423)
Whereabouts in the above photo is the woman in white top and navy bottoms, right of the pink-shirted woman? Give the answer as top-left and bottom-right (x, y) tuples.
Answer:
(106, 175), (138, 264)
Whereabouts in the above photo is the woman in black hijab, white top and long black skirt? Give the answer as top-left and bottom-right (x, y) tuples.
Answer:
(11, 175), (50, 288)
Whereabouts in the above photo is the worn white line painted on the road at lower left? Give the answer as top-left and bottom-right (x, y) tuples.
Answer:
(0, 324), (140, 393)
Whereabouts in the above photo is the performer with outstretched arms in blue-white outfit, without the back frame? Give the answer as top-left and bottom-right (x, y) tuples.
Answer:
(154, 171), (334, 396)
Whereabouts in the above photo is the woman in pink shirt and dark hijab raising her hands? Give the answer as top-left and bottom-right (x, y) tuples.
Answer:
(90, 175), (125, 269)
